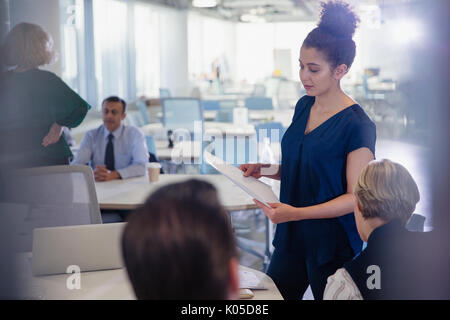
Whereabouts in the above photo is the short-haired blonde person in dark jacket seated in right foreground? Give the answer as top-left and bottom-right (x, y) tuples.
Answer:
(324, 160), (434, 300)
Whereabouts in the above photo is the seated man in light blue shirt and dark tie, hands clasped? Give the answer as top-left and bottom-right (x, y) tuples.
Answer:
(71, 97), (148, 181)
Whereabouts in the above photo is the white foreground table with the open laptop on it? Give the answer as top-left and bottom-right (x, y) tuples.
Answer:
(16, 253), (283, 300)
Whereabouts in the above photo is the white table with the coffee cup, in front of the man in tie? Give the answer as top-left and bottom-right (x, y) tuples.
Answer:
(95, 174), (279, 211)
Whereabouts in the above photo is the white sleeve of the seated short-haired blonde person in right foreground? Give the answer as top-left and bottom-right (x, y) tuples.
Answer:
(323, 268), (363, 300)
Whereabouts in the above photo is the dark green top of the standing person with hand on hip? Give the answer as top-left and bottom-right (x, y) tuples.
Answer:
(0, 69), (91, 167)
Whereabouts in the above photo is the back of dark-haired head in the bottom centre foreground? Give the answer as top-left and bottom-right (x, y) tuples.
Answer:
(122, 180), (237, 299)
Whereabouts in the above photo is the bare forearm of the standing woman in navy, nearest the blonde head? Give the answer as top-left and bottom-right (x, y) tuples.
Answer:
(293, 193), (355, 220)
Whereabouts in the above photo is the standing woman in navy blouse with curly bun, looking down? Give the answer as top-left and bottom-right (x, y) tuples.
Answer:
(240, 1), (376, 300)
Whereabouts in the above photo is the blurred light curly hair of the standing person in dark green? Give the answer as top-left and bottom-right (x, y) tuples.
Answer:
(2, 23), (56, 69)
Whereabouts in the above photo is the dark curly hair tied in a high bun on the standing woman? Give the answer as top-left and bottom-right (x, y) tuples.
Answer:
(303, 1), (359, 70)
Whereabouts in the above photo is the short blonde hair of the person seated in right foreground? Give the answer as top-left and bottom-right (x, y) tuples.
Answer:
(353, 159), (420, 225)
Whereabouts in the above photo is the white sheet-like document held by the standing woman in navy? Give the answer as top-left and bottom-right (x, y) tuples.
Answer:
(203, 151), (280, 208)
